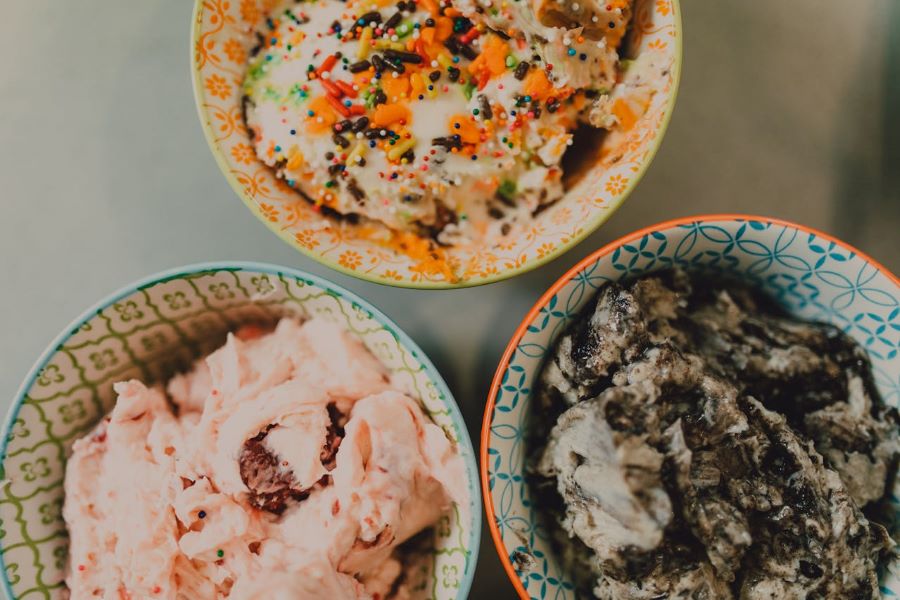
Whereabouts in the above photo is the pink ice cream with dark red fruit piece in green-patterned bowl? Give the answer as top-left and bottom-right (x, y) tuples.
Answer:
(63, 318), (468, 600)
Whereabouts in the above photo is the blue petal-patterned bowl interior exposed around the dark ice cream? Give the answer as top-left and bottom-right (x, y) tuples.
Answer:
(482, 218), (900, 600)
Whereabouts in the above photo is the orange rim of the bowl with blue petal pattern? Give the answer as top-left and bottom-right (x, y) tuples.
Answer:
(478, 213), (900, 600)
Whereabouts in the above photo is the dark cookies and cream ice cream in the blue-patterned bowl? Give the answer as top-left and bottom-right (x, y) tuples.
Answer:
(532, 271), (900, 600)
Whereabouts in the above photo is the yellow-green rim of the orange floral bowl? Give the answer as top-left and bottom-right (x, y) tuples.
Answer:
(188, 0), (684, 290)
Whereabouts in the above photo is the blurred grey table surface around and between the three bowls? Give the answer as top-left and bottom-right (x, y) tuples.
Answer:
(0, 0), (900, 599)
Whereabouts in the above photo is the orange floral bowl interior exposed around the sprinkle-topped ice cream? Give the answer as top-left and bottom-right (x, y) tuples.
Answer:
(192, 0), (681, 287)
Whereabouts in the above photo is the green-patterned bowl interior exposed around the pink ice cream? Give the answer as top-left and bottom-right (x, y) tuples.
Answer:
(0, 265), (481, 600)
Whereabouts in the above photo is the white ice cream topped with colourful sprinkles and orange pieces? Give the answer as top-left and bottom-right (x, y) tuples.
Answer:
(242, 0), (661, 244)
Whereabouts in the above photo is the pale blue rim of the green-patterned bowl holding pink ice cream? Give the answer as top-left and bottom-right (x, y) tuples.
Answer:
(0, 261), (482, 599)
